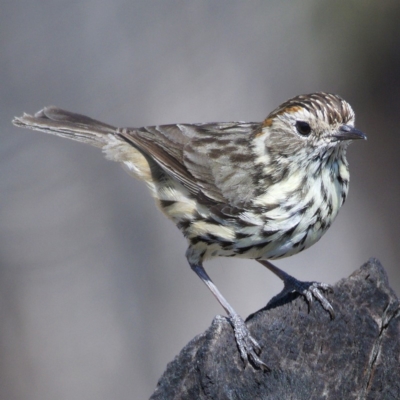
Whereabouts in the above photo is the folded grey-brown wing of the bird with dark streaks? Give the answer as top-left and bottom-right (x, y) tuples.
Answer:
(118, 122), (260, 207)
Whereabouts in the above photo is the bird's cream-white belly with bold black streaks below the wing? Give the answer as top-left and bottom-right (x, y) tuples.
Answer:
(157, 171), (342, 259)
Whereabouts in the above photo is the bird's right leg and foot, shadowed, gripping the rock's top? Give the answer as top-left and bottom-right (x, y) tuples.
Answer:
(257, 260), (335, 319)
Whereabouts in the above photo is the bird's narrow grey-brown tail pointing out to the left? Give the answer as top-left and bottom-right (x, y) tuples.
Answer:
(12, 106), (117, 147)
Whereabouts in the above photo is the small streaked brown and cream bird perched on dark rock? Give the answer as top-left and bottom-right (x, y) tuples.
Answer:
(12, 92), (367, 371)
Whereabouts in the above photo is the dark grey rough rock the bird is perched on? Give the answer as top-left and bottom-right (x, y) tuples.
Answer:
(151, 259), (400, 400)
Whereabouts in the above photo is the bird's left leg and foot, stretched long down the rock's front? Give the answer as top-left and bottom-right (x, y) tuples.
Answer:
(190, 264), (269, 371)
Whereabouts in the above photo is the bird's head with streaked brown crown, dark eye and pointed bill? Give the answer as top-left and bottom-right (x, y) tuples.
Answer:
(262, 93), (367, 159)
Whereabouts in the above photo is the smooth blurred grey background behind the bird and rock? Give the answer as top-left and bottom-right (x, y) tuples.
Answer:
(0, 0), (400, 400)
